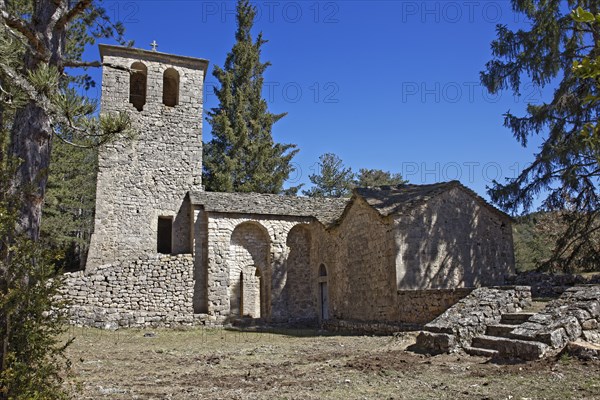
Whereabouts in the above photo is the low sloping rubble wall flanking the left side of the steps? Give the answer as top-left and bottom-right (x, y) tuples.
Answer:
(417, 286), (531, 352)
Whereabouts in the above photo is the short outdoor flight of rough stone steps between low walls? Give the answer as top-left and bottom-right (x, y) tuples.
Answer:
(464, 302), (548, 360)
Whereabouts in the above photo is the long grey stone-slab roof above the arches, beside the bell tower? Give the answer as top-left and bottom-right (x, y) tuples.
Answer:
(189, 192), (350, 226)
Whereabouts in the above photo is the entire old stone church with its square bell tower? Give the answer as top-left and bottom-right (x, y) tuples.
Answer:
(58, 45), (514, 328)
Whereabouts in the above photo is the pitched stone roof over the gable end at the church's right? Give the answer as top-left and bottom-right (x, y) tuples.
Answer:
(354, 181), (510, 219)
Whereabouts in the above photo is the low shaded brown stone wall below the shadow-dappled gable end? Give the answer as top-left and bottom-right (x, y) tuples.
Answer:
(398, 288), (473, 324)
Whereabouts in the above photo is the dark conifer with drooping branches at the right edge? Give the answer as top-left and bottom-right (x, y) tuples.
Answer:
(481, 0), (600, 271)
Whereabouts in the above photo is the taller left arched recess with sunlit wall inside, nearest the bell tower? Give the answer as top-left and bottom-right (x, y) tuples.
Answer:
(228, 222), (271, 318)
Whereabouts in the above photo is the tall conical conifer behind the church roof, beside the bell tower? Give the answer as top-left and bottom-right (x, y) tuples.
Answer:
(203, 0), (298, 193)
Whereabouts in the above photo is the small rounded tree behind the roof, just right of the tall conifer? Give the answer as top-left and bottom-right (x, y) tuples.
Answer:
(303, 153), (354, 197)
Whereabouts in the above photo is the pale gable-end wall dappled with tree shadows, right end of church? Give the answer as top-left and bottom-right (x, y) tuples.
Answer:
(395, 188), (514, 289)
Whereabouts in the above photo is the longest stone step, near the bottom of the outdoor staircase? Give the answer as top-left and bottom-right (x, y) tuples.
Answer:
(471, 335), (548, 361)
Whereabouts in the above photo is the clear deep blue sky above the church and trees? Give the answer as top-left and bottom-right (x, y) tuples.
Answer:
(86, 0), (551, 205)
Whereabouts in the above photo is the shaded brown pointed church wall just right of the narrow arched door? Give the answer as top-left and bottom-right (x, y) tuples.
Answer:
(313, 198), (399, 322)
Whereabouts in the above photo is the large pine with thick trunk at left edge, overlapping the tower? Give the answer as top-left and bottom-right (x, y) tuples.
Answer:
(0, 0), (130, 399)
